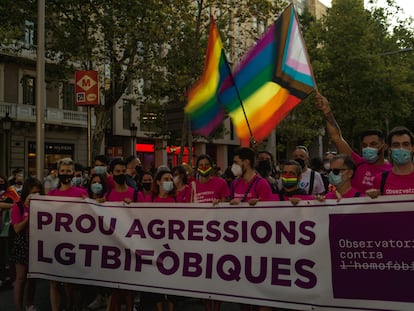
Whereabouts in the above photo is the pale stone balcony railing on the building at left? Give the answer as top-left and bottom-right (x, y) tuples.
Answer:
(0, 102), (95, 128)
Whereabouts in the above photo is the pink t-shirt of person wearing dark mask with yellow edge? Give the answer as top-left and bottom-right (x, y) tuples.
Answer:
(195, 176), (230, 203)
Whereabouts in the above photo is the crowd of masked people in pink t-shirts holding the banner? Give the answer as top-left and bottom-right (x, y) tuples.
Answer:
(0, 94), (414, 311)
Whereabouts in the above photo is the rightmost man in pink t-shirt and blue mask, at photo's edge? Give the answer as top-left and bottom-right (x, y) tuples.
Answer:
(367, 126), (414, 198)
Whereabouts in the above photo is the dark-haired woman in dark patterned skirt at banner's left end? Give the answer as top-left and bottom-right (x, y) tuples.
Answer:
(11, 177), (44, 311)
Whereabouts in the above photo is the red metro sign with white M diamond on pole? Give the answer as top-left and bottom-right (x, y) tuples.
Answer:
(75, 70), (99, 106)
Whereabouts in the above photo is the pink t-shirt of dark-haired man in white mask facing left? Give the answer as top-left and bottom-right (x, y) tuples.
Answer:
(232, 174), (273, 202)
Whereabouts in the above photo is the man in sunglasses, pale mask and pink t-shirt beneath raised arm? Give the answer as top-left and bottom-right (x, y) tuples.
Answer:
(318, 154), (365, 201)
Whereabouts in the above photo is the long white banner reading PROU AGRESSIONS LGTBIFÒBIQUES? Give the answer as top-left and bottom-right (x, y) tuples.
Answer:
(29, 196), (414, 311)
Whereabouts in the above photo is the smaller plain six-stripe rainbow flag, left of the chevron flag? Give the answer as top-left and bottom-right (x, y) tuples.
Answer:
(184, 17), (231, 136)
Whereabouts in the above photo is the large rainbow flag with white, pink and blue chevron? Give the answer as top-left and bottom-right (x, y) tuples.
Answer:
(220, 4), (316, 146)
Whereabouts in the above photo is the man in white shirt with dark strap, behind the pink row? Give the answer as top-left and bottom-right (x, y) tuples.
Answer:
(292, 146), (326, 194)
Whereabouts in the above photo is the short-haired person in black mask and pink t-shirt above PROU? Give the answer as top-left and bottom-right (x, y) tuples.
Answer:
(48, 158), (88, 311)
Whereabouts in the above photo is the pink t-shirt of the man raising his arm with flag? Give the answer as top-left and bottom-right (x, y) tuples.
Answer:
(351, 151), (392, 193)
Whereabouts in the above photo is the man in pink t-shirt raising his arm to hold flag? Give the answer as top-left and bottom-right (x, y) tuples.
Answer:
(316, 93), (391, 193)
